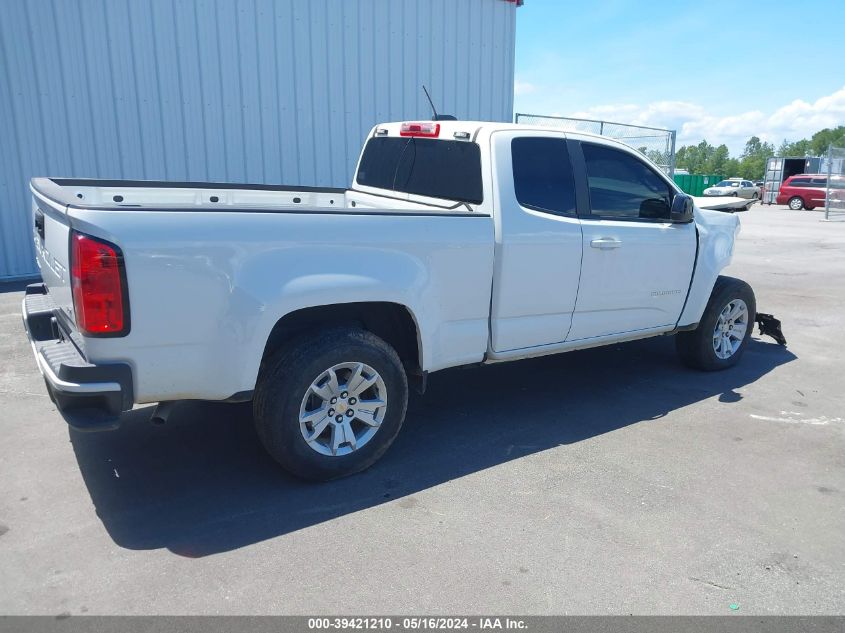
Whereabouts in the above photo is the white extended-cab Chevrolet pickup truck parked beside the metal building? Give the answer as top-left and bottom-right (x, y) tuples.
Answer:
(23, 121), (756, 480)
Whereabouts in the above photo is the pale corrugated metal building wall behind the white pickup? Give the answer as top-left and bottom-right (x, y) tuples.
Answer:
(0, 0), (517, 278)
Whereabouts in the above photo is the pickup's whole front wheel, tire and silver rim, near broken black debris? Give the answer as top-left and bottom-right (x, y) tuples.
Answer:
(675, 277), (757, 371)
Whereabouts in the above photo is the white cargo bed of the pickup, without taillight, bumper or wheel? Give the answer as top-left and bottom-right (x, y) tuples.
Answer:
(31, 178), (494, 402)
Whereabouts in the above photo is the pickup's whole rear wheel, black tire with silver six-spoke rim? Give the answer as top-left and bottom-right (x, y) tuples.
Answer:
(253, 327), (408, 481)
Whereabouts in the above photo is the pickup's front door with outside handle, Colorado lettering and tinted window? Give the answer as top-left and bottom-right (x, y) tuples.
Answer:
(567, 140), (697, 341)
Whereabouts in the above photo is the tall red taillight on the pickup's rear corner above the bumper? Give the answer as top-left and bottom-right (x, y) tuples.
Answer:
(70, 232), (129, 336)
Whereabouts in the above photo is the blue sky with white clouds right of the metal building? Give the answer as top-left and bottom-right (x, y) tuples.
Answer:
(514, 0), (845, 154)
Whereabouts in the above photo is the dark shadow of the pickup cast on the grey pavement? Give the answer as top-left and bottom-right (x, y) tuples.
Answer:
(70, 338), (795, 557)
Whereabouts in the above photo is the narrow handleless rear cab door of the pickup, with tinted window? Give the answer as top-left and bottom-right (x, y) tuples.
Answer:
(490, 130), (582, 352)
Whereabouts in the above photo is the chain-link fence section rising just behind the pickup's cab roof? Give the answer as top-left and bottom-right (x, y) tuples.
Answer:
(515, 113), (675, 178)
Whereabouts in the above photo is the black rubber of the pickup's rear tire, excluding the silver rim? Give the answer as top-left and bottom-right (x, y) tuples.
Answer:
(253, 327), (408, 481)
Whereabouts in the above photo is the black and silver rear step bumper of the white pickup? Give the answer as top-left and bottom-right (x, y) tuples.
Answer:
(22, 284), (133, 431)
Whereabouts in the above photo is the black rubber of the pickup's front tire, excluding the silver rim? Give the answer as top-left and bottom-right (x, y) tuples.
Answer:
(675, 276), (757, 371)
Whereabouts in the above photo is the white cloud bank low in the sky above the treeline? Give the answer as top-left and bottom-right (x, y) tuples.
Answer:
(567, 87), (845, 155)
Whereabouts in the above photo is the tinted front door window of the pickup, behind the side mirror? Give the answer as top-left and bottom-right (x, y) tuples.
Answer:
(581, 143), (672, 221)
